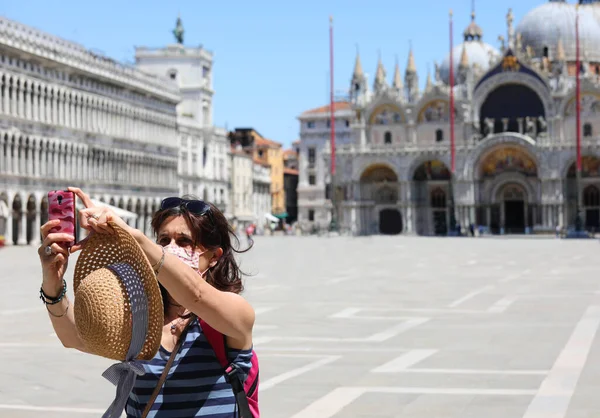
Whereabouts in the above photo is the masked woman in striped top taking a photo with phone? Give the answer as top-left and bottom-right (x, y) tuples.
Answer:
(38, 188), (255, 418)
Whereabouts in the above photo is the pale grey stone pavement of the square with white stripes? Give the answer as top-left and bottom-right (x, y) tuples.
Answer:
(0, 237), (600, 418)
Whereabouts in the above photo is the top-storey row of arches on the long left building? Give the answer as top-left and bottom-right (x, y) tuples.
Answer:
(0, 72), (177, 142)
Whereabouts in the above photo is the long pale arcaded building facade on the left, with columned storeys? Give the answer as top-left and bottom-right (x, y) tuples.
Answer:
(0, 17), (181, 244)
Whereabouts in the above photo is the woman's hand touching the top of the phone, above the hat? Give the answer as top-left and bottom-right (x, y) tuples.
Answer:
(69, 187), (135, 242)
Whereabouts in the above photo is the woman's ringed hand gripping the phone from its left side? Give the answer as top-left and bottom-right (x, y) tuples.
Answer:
(38, 219), (75, 297)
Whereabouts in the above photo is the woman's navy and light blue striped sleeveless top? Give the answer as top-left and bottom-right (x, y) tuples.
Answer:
(126, 318), (252, 418)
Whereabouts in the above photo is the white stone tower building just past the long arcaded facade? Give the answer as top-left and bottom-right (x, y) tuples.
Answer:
(135, 43), (231, 214)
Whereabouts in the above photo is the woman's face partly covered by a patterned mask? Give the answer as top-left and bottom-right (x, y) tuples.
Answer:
(157, 216), (218, 272)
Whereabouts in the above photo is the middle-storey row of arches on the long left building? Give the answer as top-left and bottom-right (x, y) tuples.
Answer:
(0, 131), (177, 187)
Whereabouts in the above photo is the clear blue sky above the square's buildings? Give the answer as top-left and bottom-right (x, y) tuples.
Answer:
(0, 0), (552, 145)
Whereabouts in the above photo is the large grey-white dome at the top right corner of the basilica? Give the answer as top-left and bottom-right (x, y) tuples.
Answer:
(516, 1), (600, 61)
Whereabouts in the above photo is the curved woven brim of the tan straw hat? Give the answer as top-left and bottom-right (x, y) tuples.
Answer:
(73, 222), (164, 360)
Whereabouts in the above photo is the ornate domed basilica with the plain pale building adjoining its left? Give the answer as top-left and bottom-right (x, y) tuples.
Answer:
(298, 1), (600, 235)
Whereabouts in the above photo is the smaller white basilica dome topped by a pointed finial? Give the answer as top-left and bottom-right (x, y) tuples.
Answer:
(440, 13), (500, 84)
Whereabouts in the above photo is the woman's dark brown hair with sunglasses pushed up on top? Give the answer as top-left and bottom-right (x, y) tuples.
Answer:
(151, 196), (252, 299)
